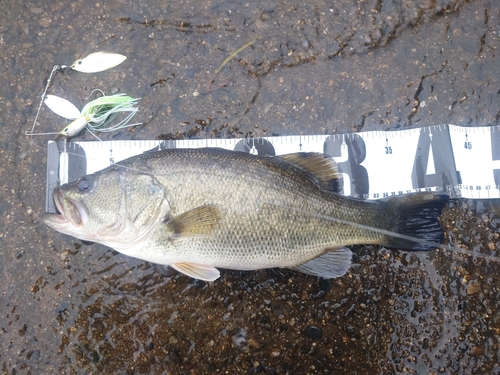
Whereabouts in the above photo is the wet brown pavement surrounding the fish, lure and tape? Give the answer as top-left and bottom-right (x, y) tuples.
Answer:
(0, 0), (500, 374)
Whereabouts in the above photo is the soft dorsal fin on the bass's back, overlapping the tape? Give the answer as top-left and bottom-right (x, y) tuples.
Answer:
(278, 152), (342, 193)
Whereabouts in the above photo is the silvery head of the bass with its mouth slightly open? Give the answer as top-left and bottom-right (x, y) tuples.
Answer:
(43, 168), (168, 249)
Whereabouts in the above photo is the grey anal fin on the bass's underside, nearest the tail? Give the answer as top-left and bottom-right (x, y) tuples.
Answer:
(288, 247), (352, 279)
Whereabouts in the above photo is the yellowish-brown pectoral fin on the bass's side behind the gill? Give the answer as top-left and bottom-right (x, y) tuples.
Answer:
(166, 206), (221, 240)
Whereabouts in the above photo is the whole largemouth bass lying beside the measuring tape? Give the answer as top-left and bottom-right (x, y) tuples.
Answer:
(43, 148), (448, 281)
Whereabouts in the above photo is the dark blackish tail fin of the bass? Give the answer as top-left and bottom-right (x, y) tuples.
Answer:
(382, 193), (450, 250)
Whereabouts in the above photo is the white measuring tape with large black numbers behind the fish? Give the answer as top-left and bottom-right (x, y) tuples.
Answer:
(46, 125), (500, 212)
